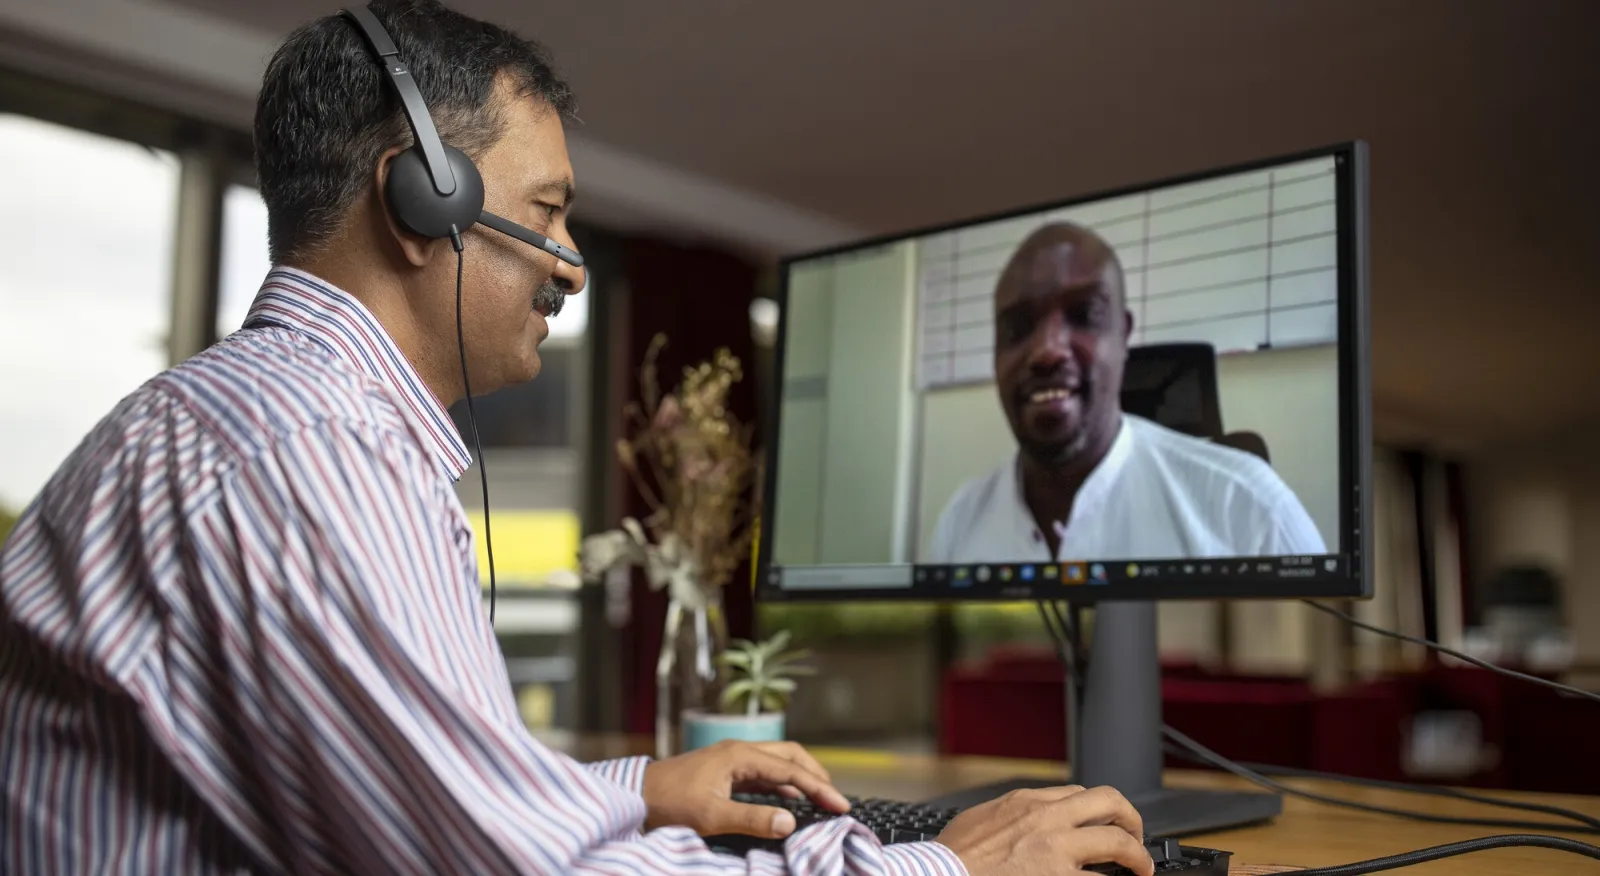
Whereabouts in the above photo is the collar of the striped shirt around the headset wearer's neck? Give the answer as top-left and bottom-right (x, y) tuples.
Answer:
(245, 267), (472, 481)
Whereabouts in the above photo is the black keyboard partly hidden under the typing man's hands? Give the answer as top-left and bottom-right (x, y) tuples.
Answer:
(706, 794), (1232, 876)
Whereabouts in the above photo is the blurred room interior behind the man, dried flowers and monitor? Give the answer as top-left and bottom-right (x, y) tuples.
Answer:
(0, 0), (1600, 791)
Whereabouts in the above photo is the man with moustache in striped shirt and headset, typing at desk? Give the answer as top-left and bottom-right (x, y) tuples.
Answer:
(0, 0), (1154, 876)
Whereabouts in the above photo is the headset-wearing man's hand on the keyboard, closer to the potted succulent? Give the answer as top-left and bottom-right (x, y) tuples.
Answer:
(645, 742), (850, 839)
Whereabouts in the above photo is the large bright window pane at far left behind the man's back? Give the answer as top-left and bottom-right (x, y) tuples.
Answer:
(0, 115), (179, 510)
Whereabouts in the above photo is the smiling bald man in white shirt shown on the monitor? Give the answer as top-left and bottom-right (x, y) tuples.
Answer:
(925, 222), (1325, 564)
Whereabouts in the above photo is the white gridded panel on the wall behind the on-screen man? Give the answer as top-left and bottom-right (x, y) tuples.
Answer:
(917, 157), (1339, 388)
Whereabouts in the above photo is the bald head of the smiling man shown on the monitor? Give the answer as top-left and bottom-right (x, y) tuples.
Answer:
(995, 222), (1133, 468)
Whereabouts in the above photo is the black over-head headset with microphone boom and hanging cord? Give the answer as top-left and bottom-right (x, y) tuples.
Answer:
(341, 5), (584, 625)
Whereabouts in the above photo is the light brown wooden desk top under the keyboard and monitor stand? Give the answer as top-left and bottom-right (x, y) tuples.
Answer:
(552, 735), (1600, 876)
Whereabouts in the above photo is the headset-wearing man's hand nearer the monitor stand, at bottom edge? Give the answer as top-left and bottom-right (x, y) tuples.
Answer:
(939, 785), (1155, 876)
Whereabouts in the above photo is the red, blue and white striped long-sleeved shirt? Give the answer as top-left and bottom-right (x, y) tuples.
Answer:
(0, 269), (963, 876)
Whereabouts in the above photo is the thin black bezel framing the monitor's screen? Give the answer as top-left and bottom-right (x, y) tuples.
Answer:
(754, 139), (1373, 603)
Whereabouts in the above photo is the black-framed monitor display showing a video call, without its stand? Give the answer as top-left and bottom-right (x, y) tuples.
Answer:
(757, 142), (1371, 601)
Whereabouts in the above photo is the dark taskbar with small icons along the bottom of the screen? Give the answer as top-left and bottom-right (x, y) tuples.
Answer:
(765, 555), (1350, 598)
